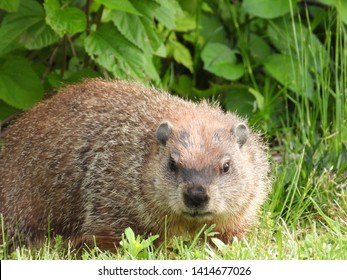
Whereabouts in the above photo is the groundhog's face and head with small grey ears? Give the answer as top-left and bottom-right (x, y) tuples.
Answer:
(155, 117), (254, 222)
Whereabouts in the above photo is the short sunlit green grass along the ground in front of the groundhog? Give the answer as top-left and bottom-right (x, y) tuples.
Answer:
(3, 203), (347, 260)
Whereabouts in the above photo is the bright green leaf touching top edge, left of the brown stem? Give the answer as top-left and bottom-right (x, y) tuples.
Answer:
(44, 0), (87, 37)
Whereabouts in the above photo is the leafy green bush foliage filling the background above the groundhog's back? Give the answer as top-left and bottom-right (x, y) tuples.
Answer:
(0, 0), (347, 120)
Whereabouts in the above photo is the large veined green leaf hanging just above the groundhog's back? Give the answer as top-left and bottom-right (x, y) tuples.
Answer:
(85, 23), (146, 79)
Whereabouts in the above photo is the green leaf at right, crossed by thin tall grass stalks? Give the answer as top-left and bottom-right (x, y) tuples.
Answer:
(264, 54), (313, 99)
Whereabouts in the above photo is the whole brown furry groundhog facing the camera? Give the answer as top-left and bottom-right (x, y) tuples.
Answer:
(0, 79), (270, 250)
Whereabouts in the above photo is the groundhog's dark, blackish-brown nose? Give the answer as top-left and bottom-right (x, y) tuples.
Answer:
(183, 185), (210, 208)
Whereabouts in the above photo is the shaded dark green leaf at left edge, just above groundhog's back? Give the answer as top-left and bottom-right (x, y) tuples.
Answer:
(0, 56), (43, 109)
